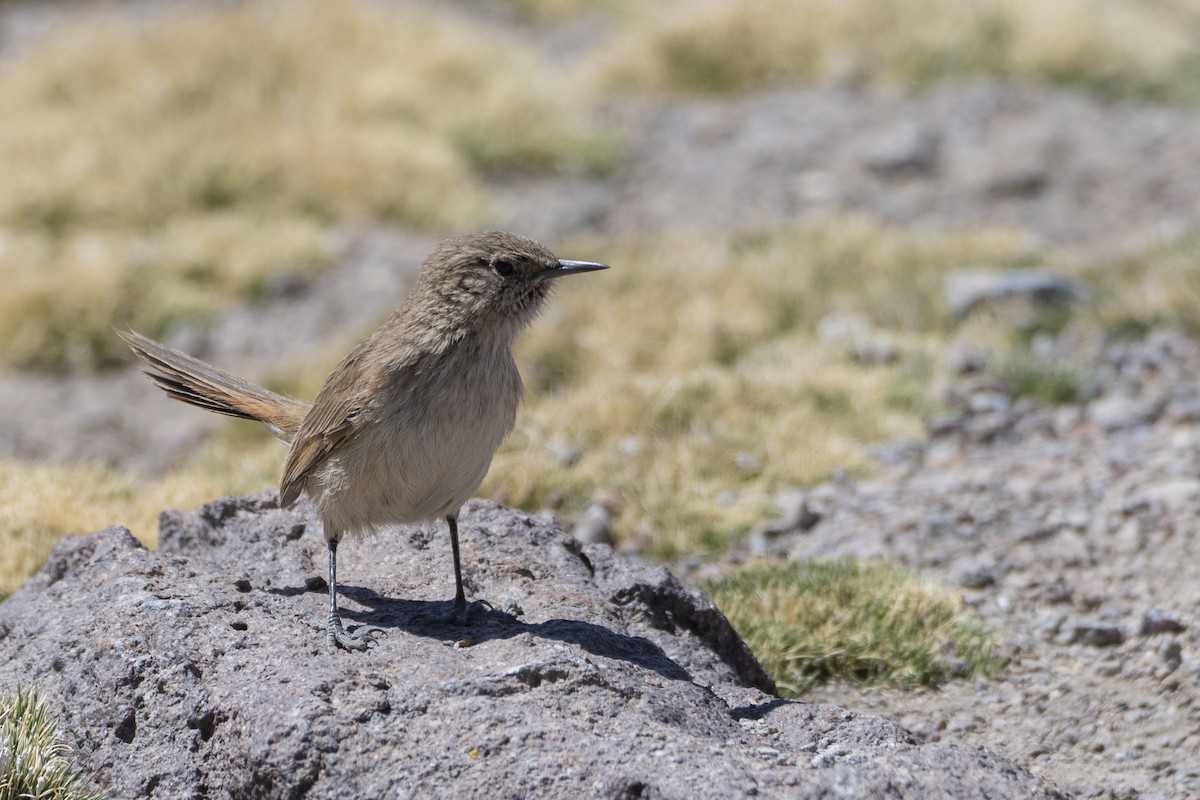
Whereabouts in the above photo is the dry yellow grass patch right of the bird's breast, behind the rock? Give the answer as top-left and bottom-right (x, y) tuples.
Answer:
(484, 219), (1200, 558)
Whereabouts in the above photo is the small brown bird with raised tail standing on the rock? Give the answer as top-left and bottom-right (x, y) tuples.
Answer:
(118, 231), (607, 650)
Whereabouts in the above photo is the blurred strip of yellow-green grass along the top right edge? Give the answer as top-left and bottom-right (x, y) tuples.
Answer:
(596, 0), (1200, 103)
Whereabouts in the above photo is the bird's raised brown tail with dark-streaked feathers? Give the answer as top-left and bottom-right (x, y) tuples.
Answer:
(116, 331), (311, 444)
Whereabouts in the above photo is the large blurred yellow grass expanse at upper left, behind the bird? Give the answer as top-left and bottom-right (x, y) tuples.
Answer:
(0, 0), (613, 368)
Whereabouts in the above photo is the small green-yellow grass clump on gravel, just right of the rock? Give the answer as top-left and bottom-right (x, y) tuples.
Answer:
(707, 560), (1002, 697)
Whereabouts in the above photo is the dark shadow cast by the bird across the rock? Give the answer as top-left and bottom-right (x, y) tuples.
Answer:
(328, 584), (691, 681)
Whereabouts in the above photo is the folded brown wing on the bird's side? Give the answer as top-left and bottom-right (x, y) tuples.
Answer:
(280, 349), (379, 506)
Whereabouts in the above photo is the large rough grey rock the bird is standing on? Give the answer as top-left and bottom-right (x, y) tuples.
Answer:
(0, 494), (1061, 798)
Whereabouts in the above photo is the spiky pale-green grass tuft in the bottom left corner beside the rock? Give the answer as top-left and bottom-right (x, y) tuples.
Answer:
(0, 686), (104, 800)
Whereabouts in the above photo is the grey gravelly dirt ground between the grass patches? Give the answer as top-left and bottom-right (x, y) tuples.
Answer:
(0, 4), (1200, 798)
